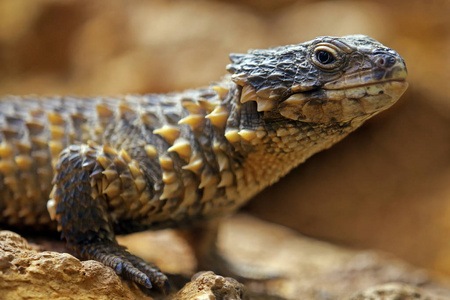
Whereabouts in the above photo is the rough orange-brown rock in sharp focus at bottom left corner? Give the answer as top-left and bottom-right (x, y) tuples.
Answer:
(0, 231), (152, 299)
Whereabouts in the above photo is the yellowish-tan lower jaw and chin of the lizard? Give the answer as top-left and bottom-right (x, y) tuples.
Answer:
(278, 79), (408, 123)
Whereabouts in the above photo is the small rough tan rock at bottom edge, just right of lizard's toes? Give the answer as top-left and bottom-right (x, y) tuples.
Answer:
(173, 271), (249, 300)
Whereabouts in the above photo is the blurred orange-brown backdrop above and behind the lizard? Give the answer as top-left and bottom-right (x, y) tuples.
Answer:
(0, 0), (450, 298)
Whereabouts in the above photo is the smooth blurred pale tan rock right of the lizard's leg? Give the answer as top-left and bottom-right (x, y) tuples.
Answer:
(213, 215), (450, 300)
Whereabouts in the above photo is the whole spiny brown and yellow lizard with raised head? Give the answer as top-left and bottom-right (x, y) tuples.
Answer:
(0, 35), (408, 289)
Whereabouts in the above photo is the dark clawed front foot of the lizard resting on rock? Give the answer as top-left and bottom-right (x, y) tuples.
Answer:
(81, 242), (169, 292)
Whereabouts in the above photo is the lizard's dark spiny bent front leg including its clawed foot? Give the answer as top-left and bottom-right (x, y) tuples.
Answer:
(48, 144), (168, 290)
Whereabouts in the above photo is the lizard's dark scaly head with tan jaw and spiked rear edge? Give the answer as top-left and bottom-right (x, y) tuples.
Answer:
(227, 35), (408, 123)
